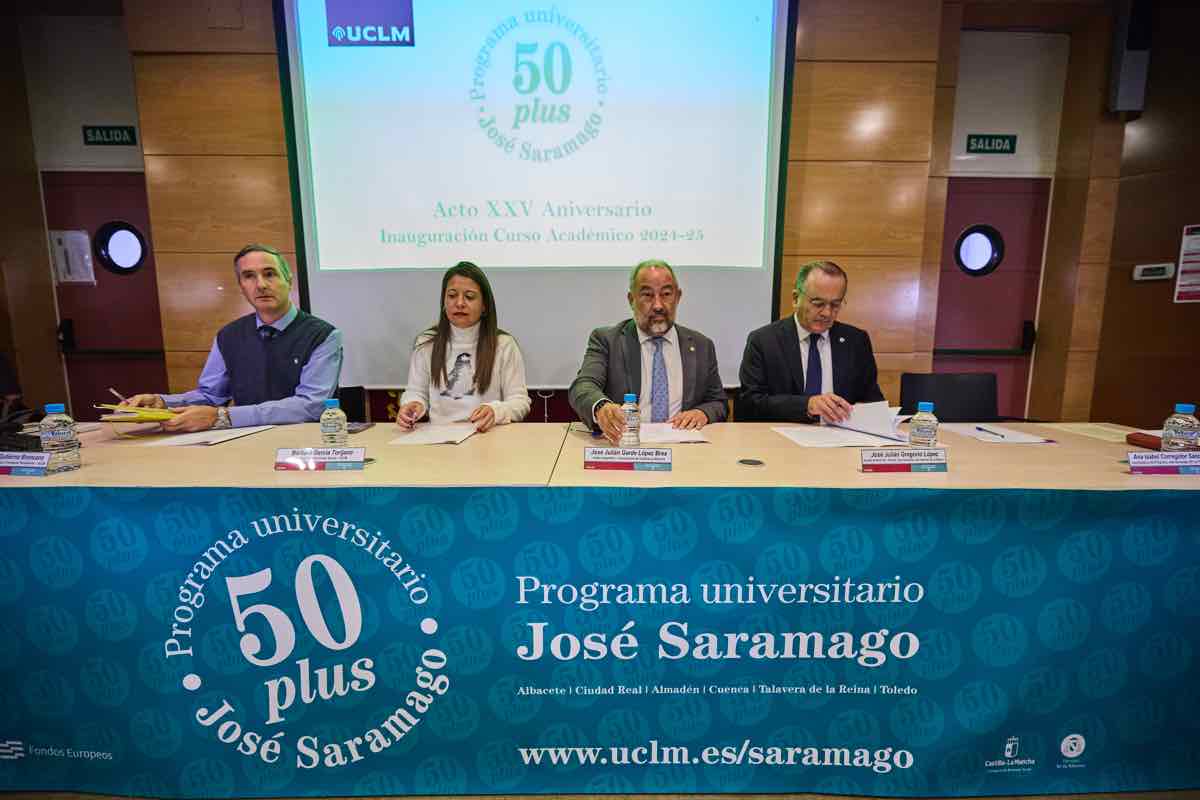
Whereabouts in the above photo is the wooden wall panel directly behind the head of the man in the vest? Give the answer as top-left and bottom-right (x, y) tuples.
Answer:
(157, 251), (299, 353)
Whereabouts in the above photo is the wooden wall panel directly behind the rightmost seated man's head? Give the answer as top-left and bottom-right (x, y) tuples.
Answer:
(779, 253), (920, 353)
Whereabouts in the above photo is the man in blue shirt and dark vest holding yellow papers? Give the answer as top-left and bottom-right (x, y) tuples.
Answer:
(125, 245), (342, 432)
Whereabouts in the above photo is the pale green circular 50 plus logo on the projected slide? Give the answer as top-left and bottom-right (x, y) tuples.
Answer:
(468, 8), (608, 163)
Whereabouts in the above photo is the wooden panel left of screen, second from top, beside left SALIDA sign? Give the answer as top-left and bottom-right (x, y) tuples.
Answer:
(133, 54), (287, 156)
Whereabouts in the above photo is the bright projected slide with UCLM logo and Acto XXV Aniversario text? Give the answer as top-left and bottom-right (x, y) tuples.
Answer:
(294, 0), (776, 271)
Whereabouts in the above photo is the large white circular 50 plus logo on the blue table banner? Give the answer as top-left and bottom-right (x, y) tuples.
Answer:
(157, 509), (450, 786)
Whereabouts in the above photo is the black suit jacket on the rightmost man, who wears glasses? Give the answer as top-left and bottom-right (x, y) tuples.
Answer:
(738, 317), (883, 422)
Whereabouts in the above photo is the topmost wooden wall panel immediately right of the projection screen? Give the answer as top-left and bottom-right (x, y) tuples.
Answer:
(796, 0), (942, 64)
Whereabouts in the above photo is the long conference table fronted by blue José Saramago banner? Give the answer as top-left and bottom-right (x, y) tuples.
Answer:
(0, 423), (1200, 798)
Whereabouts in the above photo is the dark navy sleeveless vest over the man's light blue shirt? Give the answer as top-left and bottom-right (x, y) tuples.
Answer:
(217, 309), (334, 405)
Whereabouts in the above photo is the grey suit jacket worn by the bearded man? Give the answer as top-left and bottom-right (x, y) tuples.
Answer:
(568, 319), (727, 426)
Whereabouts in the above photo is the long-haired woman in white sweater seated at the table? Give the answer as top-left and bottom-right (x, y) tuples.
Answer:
(396, 261), (529, 433)
